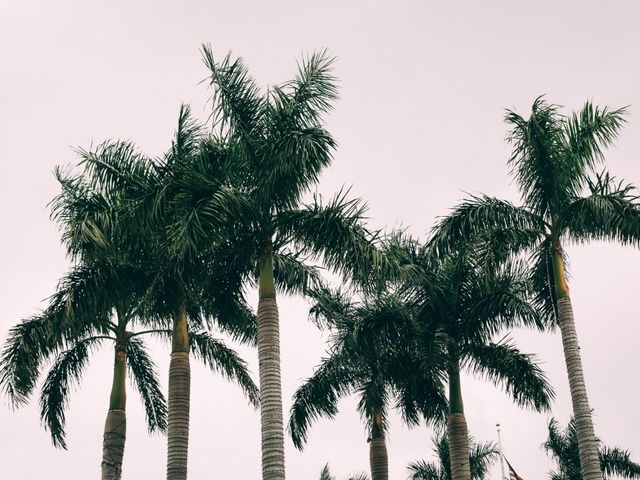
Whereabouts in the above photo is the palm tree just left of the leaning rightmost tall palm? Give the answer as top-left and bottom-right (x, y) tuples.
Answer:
(390, 235), (553, 480)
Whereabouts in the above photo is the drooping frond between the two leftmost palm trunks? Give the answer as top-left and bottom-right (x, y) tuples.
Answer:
(127, 338), (167, 433)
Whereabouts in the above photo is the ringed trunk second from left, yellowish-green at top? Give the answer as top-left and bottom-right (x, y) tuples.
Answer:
(167, 304), (191, 480)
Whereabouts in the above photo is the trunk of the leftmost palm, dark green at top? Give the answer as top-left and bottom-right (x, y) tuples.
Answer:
(102, 342), (127, 480)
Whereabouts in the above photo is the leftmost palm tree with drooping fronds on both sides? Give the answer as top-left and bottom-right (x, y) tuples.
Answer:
(0, 264), (167, 479)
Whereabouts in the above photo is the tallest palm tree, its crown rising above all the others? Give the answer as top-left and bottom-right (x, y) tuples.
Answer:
(180, 46), (390, 480)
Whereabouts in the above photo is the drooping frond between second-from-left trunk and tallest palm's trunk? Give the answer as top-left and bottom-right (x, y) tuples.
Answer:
(189, 332), (260, 407)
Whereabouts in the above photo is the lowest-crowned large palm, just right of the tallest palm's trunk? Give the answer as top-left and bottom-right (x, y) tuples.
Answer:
(289, 290), (446, 480)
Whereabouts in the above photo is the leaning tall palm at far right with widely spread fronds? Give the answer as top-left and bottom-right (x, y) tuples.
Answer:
(433, 97), (640, 480)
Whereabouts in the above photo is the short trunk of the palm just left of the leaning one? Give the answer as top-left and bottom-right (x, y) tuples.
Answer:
(447, 348), (471, 480)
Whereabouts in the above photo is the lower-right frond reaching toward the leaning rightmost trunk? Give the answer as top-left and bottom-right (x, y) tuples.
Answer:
(462, 339), (555, 411)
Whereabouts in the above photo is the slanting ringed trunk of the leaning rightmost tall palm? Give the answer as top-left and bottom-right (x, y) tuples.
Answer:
(553, 241), (602, 480)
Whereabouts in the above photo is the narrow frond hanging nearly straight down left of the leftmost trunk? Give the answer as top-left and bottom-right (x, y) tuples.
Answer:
(40, 338), (102, 449)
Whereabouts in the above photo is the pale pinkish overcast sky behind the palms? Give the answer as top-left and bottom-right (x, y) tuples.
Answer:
(0, 0), (640, 480)
